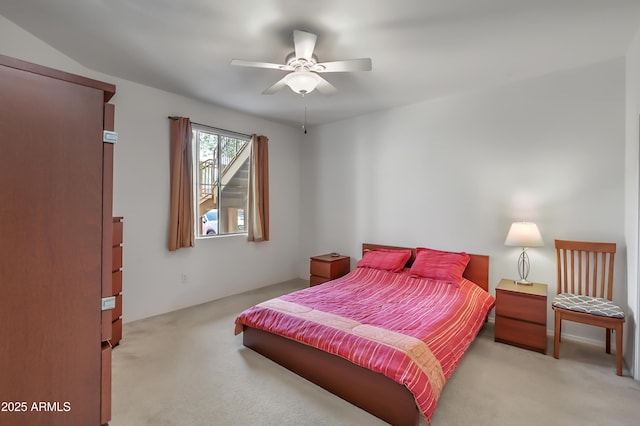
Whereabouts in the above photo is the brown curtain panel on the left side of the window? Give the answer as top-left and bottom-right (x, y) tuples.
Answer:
(169, 117), (194, 251)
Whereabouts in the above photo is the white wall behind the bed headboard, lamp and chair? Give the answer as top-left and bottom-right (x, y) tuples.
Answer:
(299, 58), (627, 348)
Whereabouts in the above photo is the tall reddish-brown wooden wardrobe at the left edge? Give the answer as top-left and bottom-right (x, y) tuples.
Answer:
(0, 55), (115, 426)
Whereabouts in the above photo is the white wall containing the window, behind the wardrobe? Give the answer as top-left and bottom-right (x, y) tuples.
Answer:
(0, 16), (300, 322)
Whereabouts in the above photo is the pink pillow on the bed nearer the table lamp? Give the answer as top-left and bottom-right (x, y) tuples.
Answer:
(409, 247), (471, 285)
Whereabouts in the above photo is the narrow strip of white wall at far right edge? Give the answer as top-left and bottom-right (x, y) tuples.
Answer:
(625, 27), (640, 380)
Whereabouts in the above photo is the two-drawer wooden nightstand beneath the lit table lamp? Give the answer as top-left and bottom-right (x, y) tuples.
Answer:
(495, 279), (547, 355)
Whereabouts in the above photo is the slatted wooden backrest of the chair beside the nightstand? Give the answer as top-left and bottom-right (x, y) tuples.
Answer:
(556, 240), (616, 300)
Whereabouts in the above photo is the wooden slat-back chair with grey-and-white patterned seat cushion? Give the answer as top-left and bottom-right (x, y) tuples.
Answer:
(551, 240), (624, 376)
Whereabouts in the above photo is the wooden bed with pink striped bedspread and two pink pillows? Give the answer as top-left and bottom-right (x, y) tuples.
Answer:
(236, 244), (495, 425)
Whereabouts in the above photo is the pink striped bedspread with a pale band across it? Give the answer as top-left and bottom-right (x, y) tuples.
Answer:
(236, 268), (495, 421)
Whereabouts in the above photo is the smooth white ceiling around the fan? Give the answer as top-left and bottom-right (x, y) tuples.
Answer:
(0, 0), (640, 126)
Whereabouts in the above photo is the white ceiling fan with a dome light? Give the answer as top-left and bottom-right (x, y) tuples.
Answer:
(231, 30), (371, 96)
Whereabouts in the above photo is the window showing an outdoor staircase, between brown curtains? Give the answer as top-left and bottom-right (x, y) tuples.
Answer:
(192, 124), (251, 237)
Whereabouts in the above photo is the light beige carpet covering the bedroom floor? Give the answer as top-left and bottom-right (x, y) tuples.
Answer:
(110, 280), (640, 426)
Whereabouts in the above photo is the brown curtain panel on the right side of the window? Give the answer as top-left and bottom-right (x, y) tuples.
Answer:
(248, 135), (269, 241)
